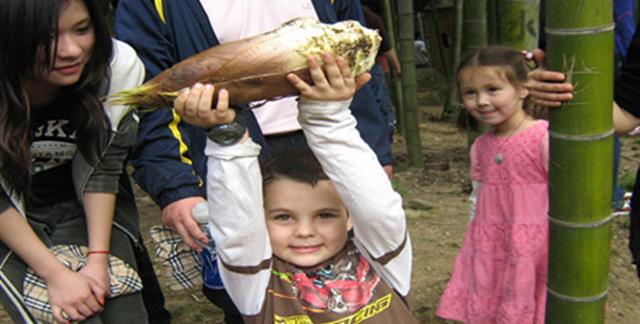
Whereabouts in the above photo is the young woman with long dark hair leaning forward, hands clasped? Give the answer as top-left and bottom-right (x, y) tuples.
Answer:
(0, 0), (146, 323)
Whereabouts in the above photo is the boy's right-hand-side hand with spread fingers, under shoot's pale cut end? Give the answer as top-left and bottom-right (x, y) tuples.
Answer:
(287, 53), (371, 101)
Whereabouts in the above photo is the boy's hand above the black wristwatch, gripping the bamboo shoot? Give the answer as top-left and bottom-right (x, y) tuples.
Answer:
(173, 83), (236, 128)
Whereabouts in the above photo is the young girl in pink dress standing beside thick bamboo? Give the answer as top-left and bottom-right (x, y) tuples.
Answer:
(436, 46), (549, 323)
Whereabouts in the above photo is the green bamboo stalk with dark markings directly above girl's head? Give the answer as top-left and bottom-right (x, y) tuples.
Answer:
(493, 0), (540, 51)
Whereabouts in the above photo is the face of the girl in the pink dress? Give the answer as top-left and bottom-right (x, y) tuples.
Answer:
(458, 66), (529, 133)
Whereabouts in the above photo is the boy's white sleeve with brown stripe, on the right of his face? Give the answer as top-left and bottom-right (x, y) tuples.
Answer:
(298, 101), (411, 295)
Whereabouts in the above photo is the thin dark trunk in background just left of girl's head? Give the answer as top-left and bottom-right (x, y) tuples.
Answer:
(440, 0), (460, 120)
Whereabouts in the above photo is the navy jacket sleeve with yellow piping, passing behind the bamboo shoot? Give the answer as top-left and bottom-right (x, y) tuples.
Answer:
(115, 0), (204, 208)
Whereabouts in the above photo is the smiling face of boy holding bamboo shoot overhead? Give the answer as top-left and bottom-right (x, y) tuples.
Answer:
(264, 178), (351, 267)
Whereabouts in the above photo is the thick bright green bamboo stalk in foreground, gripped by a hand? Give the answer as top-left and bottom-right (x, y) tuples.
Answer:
(545, 0), (614, 324)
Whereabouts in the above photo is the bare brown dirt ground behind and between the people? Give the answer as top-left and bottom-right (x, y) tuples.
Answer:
(0, 107), (640, 324)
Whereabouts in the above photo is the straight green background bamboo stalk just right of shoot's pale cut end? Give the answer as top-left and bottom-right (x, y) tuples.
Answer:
(397, 0), (424, 168)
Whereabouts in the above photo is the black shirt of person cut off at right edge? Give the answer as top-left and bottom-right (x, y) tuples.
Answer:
(615, 25), (640, 118)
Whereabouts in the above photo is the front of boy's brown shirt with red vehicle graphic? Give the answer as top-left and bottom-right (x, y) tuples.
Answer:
(251, 242), (416, 324)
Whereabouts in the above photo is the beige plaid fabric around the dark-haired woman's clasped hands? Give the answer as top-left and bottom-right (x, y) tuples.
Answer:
(23, 245), (142, 323)
